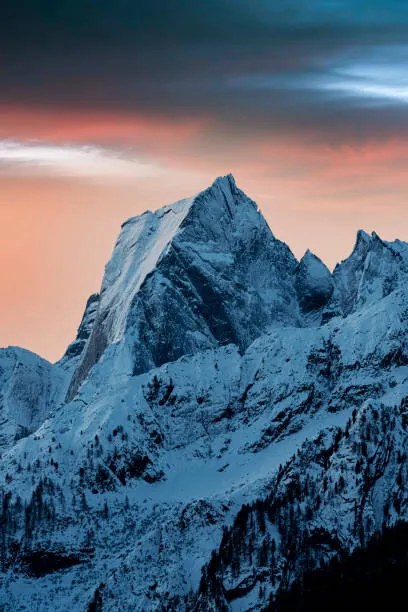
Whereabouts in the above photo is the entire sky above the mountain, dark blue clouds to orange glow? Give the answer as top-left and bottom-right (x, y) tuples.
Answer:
(0, 0), (408, 361)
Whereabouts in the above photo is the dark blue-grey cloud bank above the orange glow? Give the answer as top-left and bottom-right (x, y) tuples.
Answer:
(0, 0), (408, 141)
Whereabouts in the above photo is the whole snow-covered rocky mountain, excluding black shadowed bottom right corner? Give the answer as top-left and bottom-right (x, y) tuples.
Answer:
(0, 177), (408, 611)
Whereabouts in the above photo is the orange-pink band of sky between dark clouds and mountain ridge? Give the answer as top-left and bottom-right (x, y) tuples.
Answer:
(0, 107), (408, 360)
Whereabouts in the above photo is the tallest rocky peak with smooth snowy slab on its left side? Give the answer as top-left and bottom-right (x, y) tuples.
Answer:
(69, 175), (298, 397)
